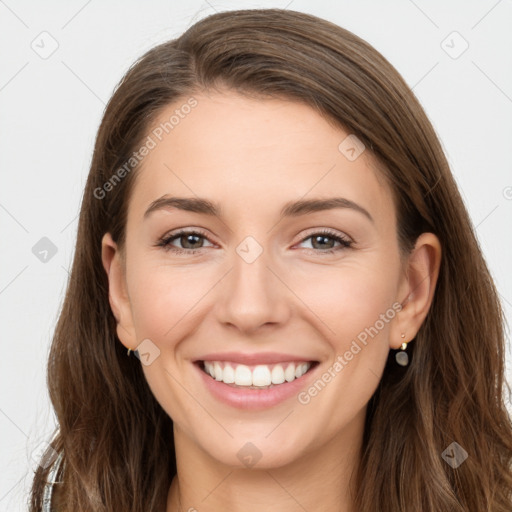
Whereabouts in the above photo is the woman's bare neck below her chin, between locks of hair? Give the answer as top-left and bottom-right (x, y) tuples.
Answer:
(167, 414), (364, 512)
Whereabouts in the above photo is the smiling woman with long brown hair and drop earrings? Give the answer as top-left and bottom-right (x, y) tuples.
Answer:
(31, 9), (512, 512)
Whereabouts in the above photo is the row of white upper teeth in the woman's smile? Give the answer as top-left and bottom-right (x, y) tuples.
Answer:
(204, 361), (311, 388)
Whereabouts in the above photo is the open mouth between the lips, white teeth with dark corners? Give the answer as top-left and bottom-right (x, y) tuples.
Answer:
(196, 361), (319, 390)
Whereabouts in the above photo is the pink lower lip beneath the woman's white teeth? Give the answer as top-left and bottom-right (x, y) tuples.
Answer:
(194, 364), (318, 409)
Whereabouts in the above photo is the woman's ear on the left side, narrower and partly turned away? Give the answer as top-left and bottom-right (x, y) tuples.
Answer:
(101, 233), (137, 350)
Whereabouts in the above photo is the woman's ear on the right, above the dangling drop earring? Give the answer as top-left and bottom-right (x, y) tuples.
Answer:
(390, 233), (442, 349)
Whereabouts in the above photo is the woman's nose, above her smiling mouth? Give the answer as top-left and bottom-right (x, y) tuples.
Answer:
(216, 244), (293, 334)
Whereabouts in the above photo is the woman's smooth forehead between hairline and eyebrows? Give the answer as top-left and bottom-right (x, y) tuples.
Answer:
(126, 92), (392, 224)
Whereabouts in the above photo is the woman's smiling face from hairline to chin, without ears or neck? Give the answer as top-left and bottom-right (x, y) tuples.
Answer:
(104, 91), (412, 467)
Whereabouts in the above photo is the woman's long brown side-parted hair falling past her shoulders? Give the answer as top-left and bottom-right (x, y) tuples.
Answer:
(30, 9), (512, 512)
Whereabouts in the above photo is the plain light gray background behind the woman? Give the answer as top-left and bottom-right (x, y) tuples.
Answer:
(0, 0), (512, 512)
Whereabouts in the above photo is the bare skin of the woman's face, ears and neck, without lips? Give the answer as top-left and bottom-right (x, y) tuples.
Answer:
(102, 90), (441, 512)
